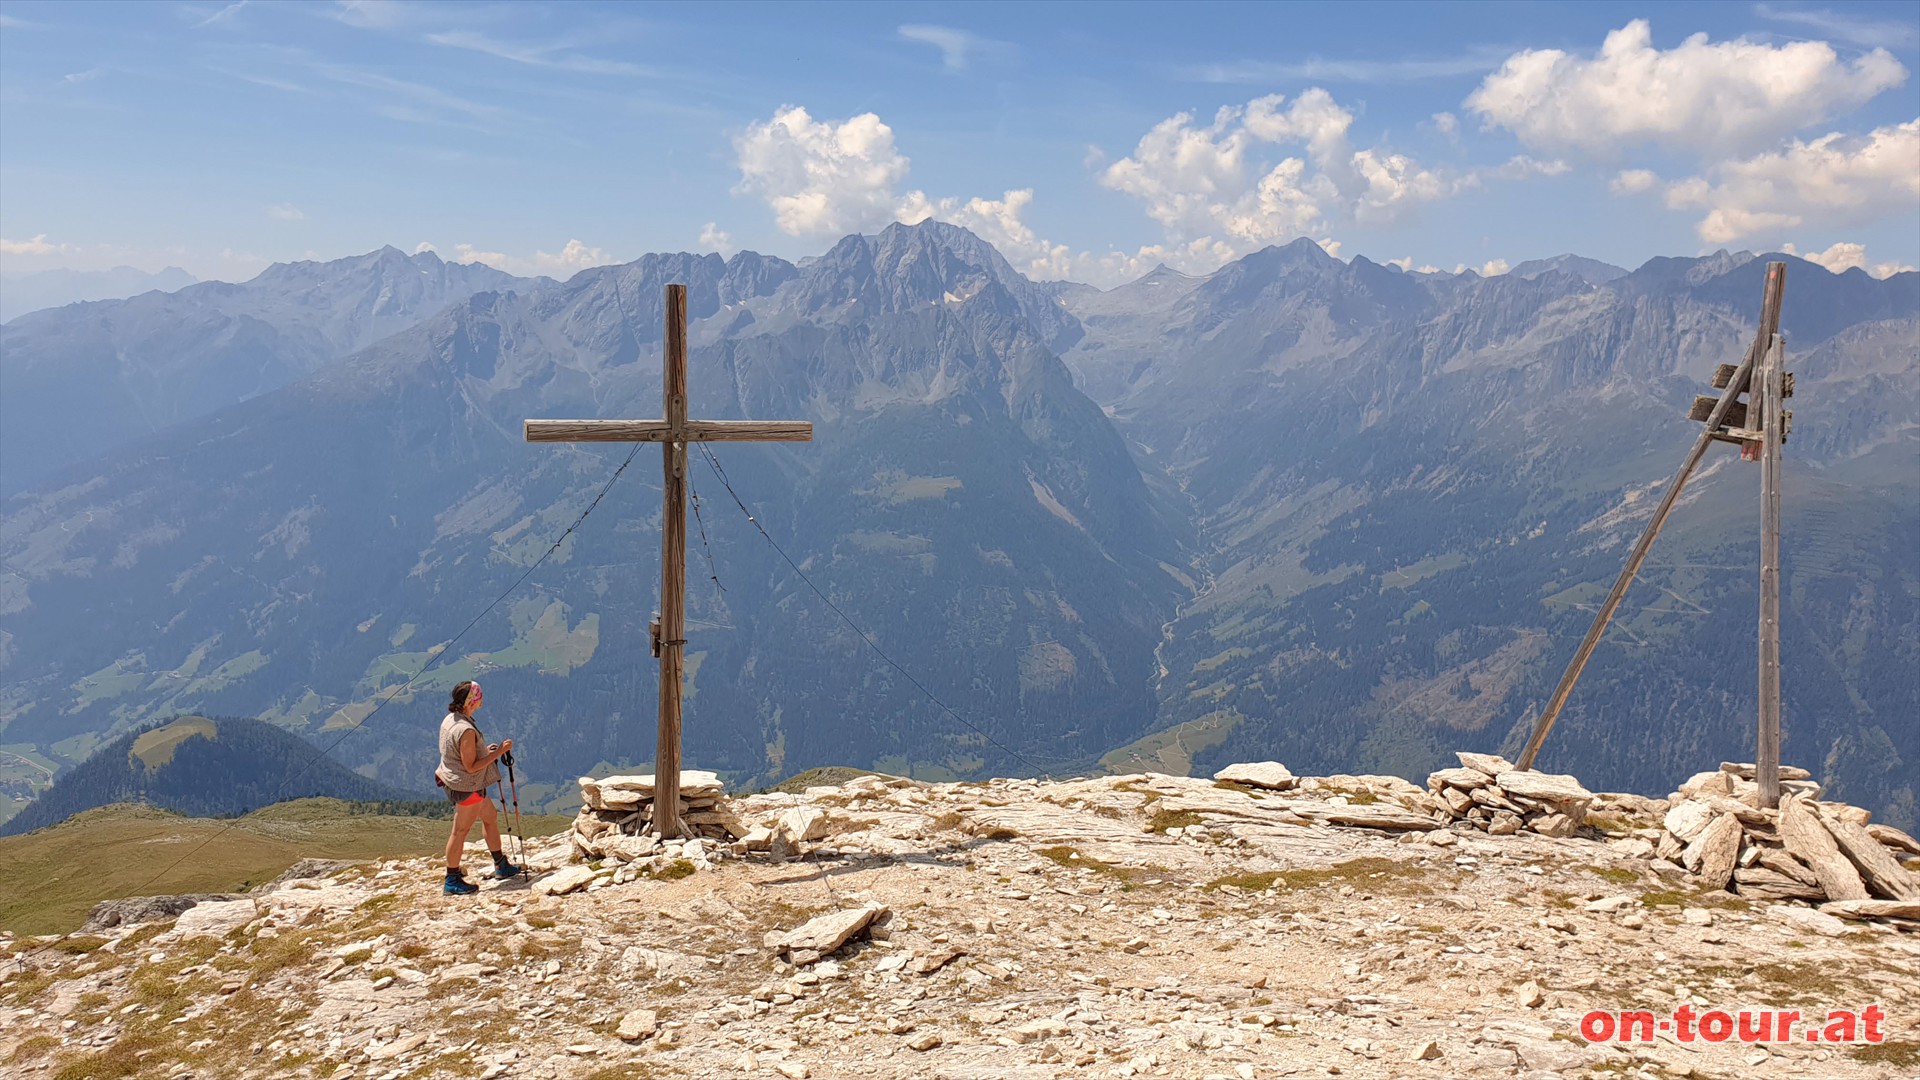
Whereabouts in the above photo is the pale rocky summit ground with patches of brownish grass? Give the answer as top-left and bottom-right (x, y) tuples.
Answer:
(0, 774), (1920, 1080)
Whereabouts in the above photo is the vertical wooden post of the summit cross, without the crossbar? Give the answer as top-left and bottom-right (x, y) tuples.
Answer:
(653, 284), (687, 840)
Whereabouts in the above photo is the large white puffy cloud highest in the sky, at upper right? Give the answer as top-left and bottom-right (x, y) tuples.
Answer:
(1465, 19), (1907, 158)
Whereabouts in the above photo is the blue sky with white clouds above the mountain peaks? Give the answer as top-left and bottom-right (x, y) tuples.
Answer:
(0, 0), (1920, 284)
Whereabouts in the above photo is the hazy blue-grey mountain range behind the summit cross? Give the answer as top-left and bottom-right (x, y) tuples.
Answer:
(0, 223), (1920, 824)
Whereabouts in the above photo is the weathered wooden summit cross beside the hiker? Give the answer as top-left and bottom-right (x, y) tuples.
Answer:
(526, 284), (814, 838)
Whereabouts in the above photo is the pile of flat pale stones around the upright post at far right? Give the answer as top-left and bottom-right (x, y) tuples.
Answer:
(1653, 763), (1920, 920)
